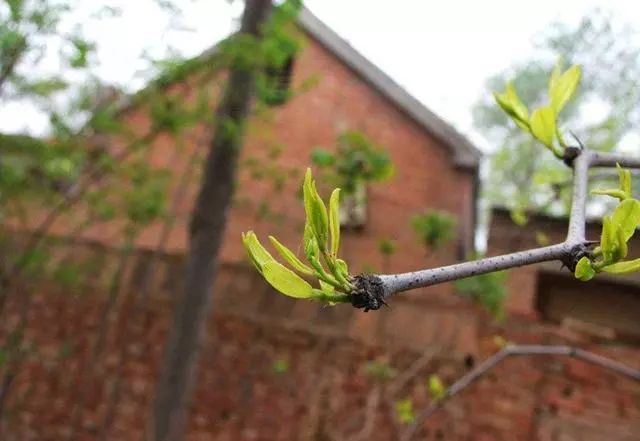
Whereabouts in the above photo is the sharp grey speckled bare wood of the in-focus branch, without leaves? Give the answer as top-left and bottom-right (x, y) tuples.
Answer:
(377, 149), (640, 300)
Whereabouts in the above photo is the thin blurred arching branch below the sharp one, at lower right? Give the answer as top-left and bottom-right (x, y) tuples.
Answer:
(401, 345), (640, 441)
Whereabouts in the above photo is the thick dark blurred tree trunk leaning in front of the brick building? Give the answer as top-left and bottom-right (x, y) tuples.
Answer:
(151, 0), (271, 441)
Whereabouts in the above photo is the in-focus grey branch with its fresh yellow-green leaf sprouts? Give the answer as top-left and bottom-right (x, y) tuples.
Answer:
(243, 60), (640, 312)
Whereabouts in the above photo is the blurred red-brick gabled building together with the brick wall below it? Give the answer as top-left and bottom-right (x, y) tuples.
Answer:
(2, 6), (640, 440)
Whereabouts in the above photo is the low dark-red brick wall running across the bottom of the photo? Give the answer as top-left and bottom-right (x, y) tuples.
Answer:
(0, 241), (640, 441)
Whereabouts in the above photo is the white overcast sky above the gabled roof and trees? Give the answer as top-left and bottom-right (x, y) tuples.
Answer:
(0, 0), (640, 150)
